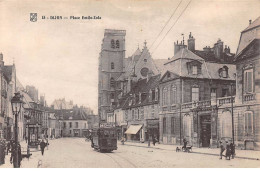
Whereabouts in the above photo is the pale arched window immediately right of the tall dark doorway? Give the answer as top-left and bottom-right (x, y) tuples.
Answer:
(220, 110), (232, 138)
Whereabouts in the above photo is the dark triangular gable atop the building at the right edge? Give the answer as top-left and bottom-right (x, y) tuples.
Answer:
(234, 39), (260, 61)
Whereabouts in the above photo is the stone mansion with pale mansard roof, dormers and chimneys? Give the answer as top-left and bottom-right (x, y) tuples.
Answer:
(159, 34), (236, 147)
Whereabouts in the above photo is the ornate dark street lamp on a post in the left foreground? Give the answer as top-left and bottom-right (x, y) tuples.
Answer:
(11, 92), (23, 168)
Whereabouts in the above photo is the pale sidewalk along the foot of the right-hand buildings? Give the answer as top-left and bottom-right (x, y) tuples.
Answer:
(122, 141), (260, 160)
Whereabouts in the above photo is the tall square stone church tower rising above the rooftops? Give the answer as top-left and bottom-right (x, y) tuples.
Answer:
(98, 29), (126, 122)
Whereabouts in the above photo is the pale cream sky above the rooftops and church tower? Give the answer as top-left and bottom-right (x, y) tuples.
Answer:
(0, 0), (260, 113)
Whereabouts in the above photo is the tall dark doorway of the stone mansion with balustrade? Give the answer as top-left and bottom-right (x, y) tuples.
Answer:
(200, 115), (211, 147)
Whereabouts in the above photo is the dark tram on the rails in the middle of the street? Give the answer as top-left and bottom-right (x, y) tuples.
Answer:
(91, 127), (117, 152)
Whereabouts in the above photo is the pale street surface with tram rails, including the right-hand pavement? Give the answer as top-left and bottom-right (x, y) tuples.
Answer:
(1, 138), (260, 168)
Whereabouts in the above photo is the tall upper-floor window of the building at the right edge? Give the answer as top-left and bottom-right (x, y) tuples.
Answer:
(244, 69), (254, 93)
